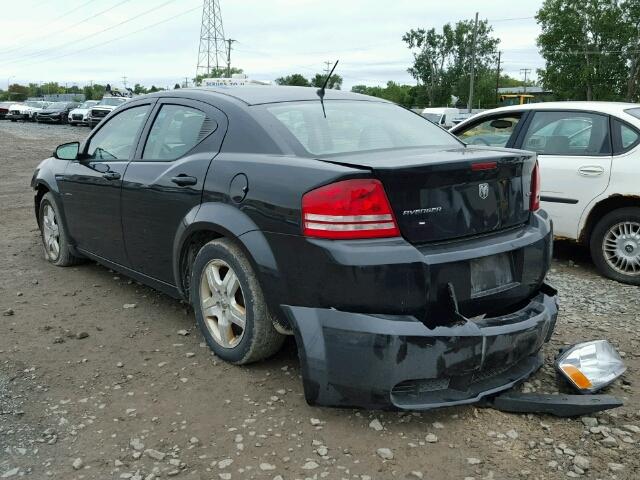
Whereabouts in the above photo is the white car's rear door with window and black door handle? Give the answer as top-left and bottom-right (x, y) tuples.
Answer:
(519, 110), (612, 239)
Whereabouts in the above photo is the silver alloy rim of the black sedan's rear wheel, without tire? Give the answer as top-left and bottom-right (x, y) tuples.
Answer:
(200, 259), (247, 348)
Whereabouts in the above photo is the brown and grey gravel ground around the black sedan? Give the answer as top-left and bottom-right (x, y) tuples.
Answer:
(0, 121), (640, 480)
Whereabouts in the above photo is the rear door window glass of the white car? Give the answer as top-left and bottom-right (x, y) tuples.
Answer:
(522, 112), (610, 156)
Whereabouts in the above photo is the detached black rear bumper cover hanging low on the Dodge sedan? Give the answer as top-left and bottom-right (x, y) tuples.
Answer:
(283, 287), (558, 410)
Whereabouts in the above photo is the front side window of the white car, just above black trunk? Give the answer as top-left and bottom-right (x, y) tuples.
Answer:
(452, 111), (523, 147)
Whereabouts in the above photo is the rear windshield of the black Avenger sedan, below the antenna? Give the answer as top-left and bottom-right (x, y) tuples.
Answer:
(266, 100), (461, 155)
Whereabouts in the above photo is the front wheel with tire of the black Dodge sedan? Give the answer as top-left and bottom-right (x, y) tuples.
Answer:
(38, 192), (82, 267)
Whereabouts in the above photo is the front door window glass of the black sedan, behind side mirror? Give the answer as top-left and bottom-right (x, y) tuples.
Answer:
(87, 105), (150, 160)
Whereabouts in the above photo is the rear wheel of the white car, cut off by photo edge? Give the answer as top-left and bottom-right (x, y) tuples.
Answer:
(589, 207), (640, 285)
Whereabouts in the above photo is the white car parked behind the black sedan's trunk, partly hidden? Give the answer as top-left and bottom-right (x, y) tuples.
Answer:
(451, 102), (640, 285)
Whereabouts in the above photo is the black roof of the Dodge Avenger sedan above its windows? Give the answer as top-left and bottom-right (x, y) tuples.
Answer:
(166, 85), (387, 105)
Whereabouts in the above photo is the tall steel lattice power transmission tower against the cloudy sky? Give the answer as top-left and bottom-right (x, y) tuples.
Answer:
(196, 0), (227, 77)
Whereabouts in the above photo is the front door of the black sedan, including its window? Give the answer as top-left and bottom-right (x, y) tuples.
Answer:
(60, 101), (153, 266)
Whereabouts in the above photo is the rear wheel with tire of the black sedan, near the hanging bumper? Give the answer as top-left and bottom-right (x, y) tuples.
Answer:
(190, 239), (284, 365)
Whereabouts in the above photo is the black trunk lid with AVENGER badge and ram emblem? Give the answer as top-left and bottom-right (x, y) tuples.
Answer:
(325, 147), (535, 244)
